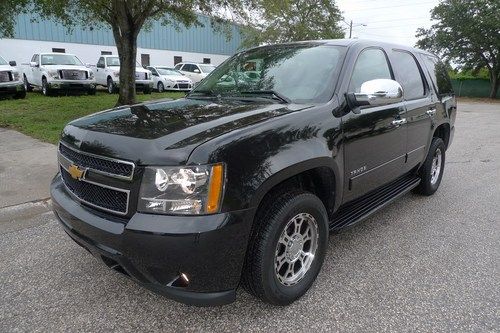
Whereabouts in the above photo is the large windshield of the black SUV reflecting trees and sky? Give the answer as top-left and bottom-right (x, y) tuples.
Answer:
(190, 43), (346, 103)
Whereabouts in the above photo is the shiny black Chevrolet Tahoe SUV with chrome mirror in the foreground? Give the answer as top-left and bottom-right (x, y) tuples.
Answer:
(51, 40), (456, 305)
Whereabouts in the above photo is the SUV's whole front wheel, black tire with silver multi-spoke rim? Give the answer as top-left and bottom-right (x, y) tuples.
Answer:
(242, 191), (329, 305)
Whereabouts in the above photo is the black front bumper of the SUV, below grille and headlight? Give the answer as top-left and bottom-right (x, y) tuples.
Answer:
(51, 175), (255, 306)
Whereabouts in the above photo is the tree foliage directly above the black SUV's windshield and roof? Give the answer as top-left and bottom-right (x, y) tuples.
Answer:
(243, 0), (344, 47)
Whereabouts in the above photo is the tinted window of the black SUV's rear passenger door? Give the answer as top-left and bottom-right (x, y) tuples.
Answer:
(392, 51), (425, 100)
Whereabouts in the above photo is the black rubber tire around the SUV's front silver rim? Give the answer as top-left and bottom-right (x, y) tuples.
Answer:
(242, 191), (329, 305)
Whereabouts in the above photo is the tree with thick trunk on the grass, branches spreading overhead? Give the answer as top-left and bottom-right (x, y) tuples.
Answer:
(0, 0), (254, 105)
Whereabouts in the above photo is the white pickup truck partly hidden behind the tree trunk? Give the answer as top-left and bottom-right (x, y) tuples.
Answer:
(95, 55), (153, 94)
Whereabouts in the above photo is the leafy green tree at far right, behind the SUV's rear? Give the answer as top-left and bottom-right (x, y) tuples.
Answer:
(416, 0), (500, 98)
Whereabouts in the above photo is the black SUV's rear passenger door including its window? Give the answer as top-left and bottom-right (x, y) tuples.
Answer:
(390, 50), (436, 171)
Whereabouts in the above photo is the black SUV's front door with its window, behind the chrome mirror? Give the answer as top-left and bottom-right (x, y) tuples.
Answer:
(342, 48), (406, 202)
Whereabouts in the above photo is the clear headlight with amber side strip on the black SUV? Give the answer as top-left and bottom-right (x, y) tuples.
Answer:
(138, 163), (224, 215)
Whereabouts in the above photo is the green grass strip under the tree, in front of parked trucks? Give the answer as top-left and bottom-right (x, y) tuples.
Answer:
(0, 91), (184, 144)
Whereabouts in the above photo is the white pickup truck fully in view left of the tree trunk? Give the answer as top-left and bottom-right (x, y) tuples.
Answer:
(22, 53), (96, 96)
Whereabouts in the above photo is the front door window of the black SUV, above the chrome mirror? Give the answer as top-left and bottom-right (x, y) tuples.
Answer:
(349, 49), (392, 93)
